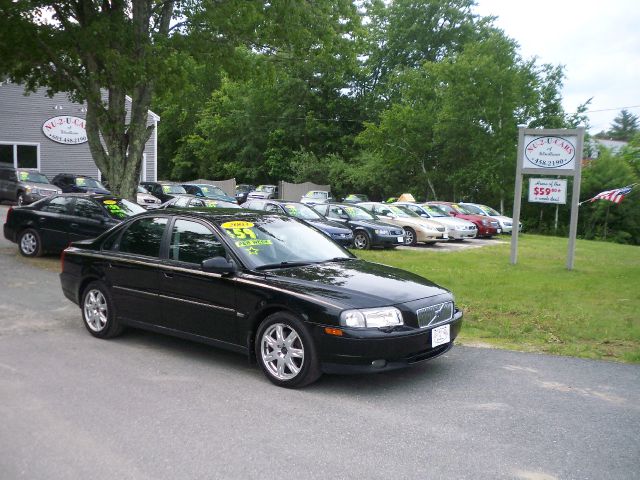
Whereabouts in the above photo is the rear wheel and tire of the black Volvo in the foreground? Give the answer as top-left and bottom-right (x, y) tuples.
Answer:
(80, 281), (123, 338)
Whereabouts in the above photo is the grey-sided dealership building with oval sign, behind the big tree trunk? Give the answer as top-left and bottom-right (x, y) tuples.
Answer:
(0, 81), (160, 181)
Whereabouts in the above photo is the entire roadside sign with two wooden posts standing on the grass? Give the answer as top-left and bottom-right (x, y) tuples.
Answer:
(511, 127), (584, 270)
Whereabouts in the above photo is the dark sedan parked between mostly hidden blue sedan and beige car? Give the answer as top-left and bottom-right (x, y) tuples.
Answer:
(313, 203), (405, 250)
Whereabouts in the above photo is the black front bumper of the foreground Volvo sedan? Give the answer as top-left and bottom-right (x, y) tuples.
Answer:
(314, 310), (462, 373)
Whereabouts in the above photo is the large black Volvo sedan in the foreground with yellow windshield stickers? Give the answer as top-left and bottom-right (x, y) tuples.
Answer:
(60, 210), (462, 387)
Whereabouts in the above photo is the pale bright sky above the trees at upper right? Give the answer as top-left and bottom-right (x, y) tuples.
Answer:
(475, 0), (640, 134)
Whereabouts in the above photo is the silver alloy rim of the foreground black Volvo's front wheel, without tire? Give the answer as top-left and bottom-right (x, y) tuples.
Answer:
(260, 323), (304, 380)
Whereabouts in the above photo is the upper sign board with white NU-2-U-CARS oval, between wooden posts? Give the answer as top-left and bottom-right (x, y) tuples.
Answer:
(522, 135), (577, 170)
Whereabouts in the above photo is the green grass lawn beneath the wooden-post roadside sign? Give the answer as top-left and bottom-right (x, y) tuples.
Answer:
(357, 235), (640, 362)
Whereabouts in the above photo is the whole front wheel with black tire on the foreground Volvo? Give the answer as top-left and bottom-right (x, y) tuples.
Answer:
(255, 312), (321, 388)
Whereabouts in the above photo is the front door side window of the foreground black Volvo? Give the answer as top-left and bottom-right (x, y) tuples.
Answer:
(169, 219), (226, 265)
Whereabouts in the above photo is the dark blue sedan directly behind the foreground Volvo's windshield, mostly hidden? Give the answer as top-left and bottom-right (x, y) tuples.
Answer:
(242, 199), (353, 247)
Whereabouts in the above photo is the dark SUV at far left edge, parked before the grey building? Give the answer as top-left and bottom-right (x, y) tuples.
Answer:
(0, 166), (61, 205)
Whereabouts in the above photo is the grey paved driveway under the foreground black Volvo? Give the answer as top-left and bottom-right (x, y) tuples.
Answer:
(0, 204), (640, 480)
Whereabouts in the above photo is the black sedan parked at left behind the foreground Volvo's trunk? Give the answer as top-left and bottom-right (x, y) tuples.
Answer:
(4, 193), (146, 257)
